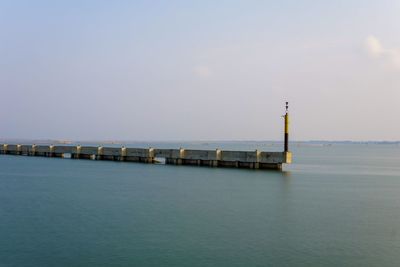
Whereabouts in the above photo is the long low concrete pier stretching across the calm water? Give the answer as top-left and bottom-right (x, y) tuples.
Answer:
(0, 144), (292, 170)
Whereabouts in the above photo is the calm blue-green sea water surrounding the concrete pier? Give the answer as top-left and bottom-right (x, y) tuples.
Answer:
(0, 143), (400, 267)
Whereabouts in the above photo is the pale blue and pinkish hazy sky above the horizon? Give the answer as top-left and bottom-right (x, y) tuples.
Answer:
(0, 0), (400, 141)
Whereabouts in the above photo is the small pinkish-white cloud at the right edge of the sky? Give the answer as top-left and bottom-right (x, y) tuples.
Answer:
(365, 35), (400, 69)
